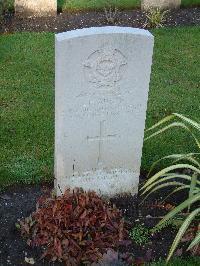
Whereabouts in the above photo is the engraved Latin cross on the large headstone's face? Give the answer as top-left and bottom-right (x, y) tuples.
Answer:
(87, 120), (117, 169)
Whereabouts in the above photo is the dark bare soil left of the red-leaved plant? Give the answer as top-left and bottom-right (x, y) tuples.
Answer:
(0, 186), (61, 266)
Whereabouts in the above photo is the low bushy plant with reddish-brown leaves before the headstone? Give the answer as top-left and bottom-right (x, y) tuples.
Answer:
(20, 189), (128, 265)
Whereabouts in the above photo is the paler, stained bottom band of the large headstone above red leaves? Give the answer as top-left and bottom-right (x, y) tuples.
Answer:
(55, 169), (139, 197)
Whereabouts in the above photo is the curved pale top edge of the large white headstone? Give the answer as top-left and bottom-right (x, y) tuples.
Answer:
(55, 26), (154, 41)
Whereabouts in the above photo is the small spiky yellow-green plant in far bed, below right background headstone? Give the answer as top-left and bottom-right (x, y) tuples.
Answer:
(144, 8), (169, 28)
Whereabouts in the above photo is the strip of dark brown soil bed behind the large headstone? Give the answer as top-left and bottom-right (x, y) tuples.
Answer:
(0, 7), (200, 33)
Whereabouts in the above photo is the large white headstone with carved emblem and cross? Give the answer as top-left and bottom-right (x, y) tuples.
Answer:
(55, 27), (154, 196)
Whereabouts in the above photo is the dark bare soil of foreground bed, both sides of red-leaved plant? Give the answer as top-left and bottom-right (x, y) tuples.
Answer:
(0, 179), (194, 266)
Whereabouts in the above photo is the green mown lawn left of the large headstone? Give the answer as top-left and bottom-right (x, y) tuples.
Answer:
(0, 33), (54, 188)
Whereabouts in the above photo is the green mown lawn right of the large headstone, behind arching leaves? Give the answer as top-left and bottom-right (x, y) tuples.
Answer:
(142, 27), (200, 170)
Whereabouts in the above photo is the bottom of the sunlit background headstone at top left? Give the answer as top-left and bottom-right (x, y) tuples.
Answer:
(15, 0), (57, 16)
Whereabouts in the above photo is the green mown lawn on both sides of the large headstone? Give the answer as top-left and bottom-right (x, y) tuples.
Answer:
(0, 27), (200, 187)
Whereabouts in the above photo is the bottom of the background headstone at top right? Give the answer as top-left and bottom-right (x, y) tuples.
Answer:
(141, 0), (181, 10)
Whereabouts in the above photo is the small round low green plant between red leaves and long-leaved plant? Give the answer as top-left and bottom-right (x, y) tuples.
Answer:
(129, 224), (150, 245)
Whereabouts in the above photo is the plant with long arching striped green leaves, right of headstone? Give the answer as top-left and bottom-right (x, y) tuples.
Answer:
(141, 113), (200, 261)
